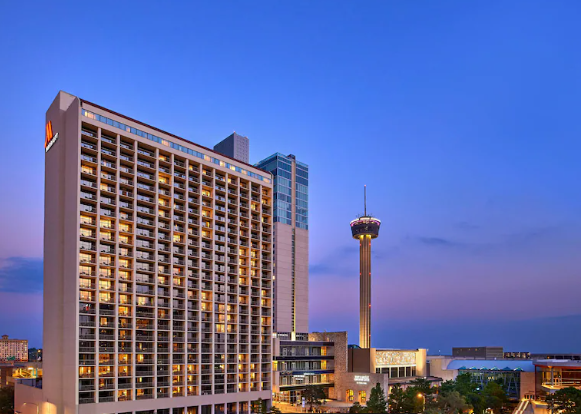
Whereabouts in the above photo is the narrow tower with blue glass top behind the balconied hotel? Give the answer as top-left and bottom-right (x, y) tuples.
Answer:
(256, 153), (309, 339)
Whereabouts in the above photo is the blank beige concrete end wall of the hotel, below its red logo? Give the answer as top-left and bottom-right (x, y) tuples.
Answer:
(42, 92), (80, 414)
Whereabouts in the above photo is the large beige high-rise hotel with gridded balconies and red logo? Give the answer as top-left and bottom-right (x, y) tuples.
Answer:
(36, 92), (274, 414)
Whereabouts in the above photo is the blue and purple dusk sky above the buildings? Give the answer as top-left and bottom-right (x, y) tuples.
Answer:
(0, 0), (581, 353)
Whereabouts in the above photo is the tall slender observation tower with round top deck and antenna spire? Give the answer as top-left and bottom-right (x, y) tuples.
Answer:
(351, 186), (381, 348)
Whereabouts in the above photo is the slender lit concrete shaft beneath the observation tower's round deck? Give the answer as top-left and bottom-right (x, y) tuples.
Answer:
(359, 234), (371, 348)
